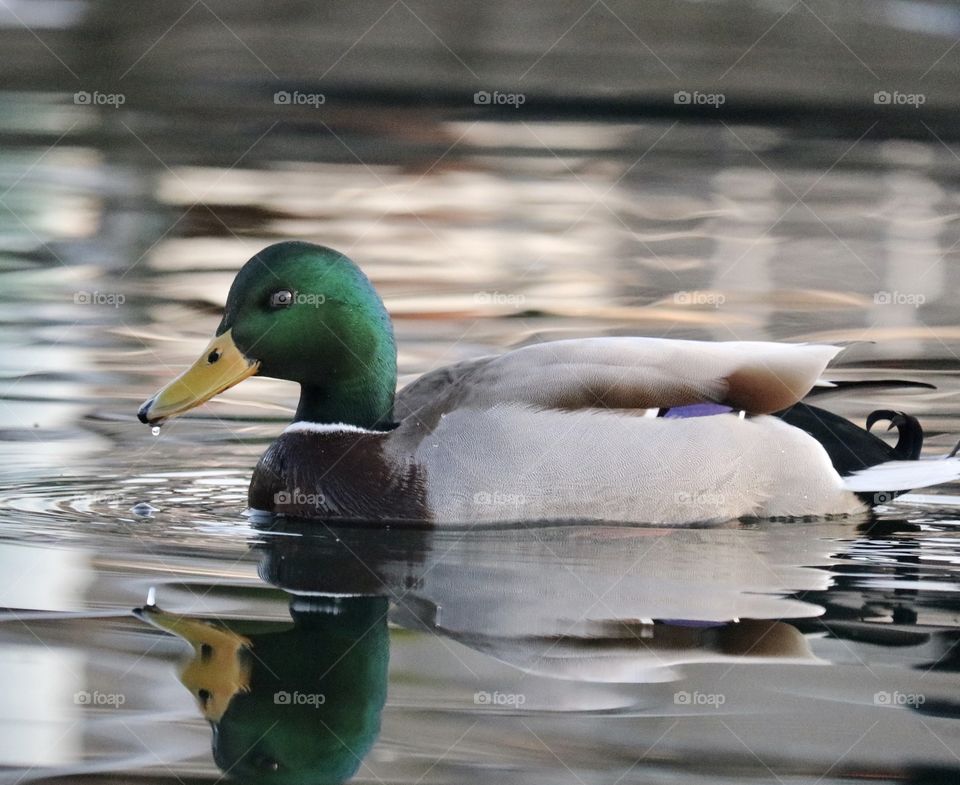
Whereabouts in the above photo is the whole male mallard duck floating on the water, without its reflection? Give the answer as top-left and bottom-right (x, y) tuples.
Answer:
(139, 242), (960, 525)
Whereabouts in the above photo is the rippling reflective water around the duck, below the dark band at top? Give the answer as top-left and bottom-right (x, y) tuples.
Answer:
(0, 26), (960, 784)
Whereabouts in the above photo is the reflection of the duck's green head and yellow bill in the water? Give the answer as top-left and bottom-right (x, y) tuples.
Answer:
(136, 597), (389, 783)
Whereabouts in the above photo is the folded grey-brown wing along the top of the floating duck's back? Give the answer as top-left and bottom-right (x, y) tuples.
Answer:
(396, 337), (842, 424)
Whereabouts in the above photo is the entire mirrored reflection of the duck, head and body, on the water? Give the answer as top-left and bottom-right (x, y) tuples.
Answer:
(137, 521), (848, 782)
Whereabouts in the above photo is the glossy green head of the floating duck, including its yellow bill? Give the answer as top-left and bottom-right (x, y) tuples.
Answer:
(138, 242), (397, 428)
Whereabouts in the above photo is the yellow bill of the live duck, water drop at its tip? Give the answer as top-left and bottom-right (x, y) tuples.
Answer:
(137, 330), (260, 425)
